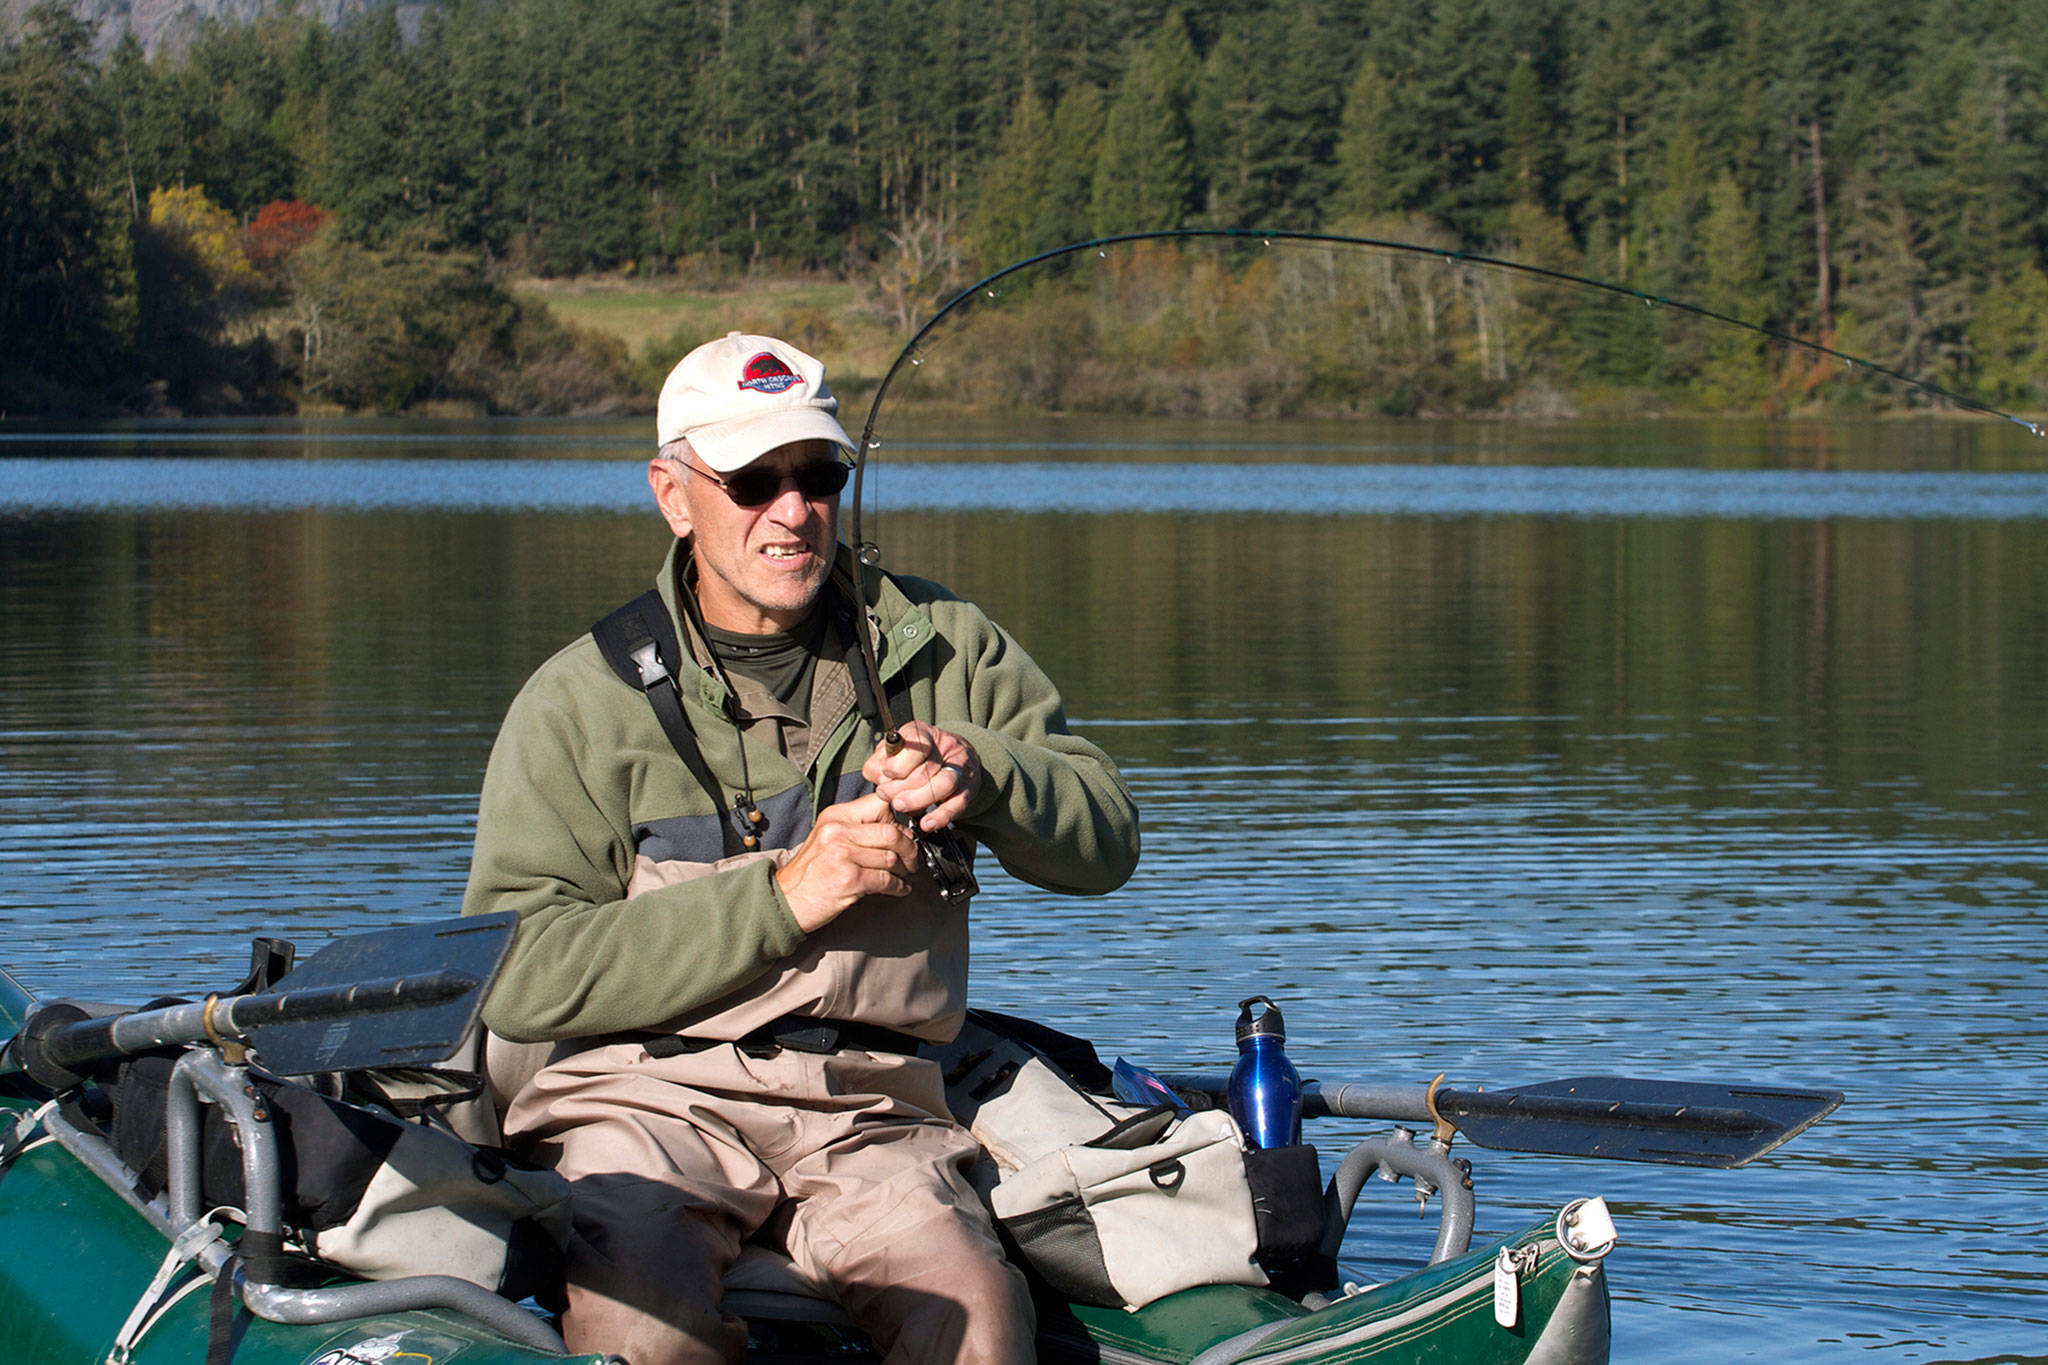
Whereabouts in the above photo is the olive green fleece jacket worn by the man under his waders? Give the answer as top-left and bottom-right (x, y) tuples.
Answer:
(463, 544), (1139, 1042)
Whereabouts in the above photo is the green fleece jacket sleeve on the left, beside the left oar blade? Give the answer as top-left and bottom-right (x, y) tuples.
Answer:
(463, 677), (805, 1042)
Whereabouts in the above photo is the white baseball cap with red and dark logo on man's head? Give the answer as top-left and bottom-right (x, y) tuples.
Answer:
(653, 332), (854, 475)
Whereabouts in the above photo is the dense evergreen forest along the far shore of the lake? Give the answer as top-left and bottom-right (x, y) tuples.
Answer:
(0, 0), (2048, 415)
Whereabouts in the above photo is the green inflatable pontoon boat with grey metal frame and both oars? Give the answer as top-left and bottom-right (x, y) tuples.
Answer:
(0, 917), (1841, 1365)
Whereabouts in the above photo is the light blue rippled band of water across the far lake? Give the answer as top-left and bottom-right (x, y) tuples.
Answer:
(12, 458), (2048, 520)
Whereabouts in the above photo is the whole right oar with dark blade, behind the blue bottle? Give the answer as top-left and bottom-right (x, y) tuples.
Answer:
(1161, 1072), (1841, 1169)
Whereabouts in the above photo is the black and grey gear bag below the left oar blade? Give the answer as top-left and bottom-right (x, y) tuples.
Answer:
(109, 1054), (569, 1300)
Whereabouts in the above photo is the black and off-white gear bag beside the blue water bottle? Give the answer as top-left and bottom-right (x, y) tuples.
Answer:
(930, 1011), (1323, 1310)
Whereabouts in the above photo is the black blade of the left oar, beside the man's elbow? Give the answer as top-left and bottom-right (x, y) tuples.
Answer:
(250, 913), (518, 1076)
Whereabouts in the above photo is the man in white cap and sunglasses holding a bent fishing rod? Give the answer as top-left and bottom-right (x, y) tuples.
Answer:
(465, 332), (1139, 1365)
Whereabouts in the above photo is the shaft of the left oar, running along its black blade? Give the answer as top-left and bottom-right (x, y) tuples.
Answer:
(41, 972), (477, 1068)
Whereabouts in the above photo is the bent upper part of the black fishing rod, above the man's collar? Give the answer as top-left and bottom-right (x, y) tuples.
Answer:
(850, 227), (2048, 565)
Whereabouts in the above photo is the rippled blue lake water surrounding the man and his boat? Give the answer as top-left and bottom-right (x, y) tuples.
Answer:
(0, 417), (2048, 1363)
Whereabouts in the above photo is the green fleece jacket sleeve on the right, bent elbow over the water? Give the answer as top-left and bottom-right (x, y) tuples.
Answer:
(926, 600), (1139, 894)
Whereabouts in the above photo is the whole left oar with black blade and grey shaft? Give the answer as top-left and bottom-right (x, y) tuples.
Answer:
(10, 913), (518, 1091)
